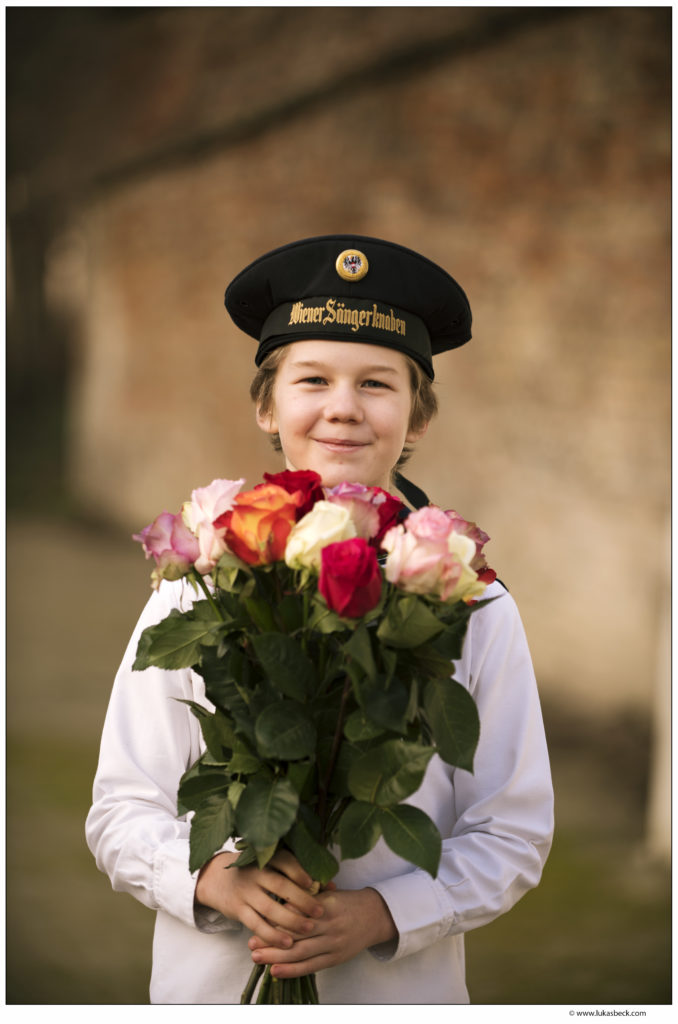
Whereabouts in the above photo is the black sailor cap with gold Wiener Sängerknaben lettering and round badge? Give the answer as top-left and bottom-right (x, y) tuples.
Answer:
(225, 234), (471, 380)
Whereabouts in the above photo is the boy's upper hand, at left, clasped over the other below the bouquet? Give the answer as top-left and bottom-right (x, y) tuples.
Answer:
(196, 851), (325, 949)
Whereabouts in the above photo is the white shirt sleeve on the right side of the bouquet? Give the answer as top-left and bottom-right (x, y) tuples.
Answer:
(373, 585), (553, 958)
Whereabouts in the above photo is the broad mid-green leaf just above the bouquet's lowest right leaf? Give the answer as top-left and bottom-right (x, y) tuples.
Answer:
(348, 739), (434, 806)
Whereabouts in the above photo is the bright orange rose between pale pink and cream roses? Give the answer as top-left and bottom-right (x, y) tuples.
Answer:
(214, 483), (304, 565)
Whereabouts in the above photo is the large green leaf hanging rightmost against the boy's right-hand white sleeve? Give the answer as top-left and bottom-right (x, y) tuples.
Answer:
(424, 679), (480, 772)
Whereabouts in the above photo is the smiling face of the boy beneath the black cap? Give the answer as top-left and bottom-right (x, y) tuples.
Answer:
(257, 341), (424, 489)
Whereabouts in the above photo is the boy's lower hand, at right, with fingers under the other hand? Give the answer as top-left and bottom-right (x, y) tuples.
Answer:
(249, 889), (397, 978)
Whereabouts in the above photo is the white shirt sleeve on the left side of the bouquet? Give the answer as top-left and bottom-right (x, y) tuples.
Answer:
(86, 582), (240, 931)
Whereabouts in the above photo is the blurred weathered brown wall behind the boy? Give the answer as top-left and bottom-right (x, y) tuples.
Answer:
(11, 7), (671, 711)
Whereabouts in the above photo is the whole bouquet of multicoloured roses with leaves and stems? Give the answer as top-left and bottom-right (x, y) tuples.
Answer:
(134, 471), (495, 1002)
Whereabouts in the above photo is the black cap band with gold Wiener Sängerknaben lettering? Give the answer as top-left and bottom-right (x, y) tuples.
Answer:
(256, 295), (433, 377)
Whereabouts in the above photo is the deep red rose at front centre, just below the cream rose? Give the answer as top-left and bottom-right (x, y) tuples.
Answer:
(317, 537), (381, 618)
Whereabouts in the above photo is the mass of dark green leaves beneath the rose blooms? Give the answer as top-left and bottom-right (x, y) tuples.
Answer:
(134, 557), (481, 885)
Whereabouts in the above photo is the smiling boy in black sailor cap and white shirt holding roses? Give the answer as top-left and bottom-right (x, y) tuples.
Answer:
(88, 236), (552, 1004)
